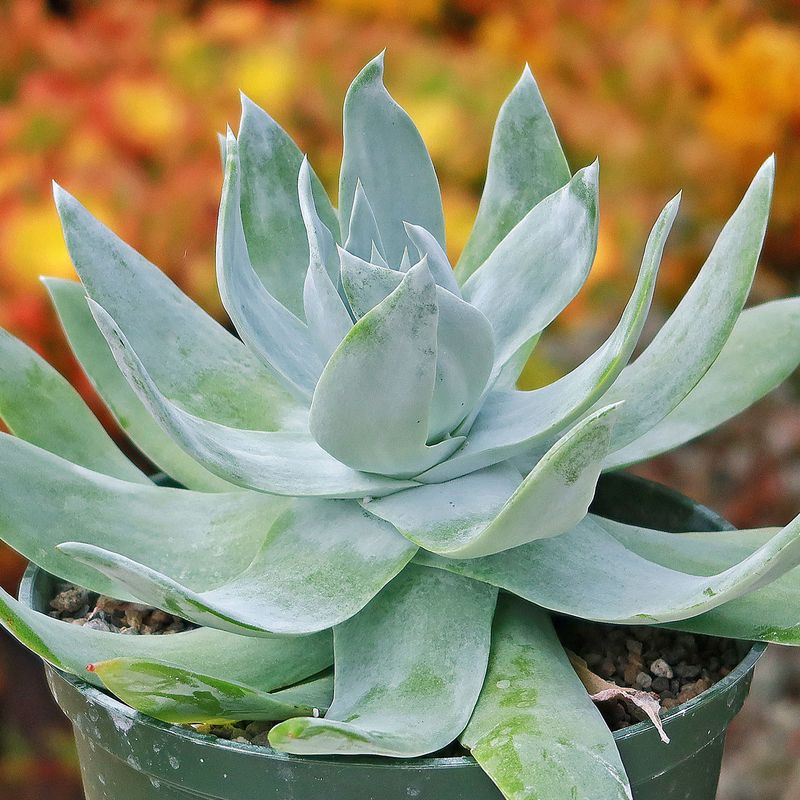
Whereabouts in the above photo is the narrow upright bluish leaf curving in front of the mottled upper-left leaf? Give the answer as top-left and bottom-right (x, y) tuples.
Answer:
(217, 131), (322, 397)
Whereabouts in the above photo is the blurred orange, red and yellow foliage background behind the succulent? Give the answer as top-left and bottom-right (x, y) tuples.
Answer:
(0, 0), (800, 800)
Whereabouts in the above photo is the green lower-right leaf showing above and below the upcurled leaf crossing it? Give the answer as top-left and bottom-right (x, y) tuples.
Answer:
(608, 524), (800, 645)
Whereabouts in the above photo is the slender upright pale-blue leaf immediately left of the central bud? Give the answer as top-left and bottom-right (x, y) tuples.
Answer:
(297, 159), (353, 361)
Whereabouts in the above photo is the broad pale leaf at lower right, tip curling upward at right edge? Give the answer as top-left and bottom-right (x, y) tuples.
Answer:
(417, 514), (800, 624)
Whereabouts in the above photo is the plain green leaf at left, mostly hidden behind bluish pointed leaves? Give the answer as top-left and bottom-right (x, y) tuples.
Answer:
(41, 278), (239, 492)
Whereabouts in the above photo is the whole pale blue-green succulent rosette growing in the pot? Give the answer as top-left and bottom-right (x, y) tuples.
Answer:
(0, 56), (800, 799)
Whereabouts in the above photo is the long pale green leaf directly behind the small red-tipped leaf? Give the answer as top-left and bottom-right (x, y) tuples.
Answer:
(0, 588), (333, 692)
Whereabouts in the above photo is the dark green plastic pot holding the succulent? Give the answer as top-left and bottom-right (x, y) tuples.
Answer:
(20, 475), (766, 800)
